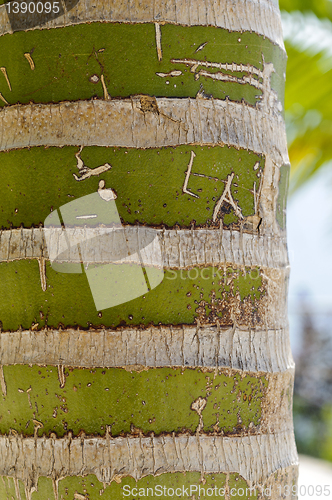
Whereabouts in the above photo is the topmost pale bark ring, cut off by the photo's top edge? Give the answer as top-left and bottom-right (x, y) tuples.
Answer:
(0, 0), (285, 50)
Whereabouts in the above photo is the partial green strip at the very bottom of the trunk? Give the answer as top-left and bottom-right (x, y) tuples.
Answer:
(0, 472), (258, 500)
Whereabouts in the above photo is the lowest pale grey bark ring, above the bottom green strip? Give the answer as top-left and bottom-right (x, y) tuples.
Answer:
(0, 431), (298, 490)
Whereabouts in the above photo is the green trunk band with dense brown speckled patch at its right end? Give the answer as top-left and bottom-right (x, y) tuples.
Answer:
(0, 260), (266, 330)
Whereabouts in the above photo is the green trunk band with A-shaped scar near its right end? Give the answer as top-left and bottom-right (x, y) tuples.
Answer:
(0, 146), (265, 228)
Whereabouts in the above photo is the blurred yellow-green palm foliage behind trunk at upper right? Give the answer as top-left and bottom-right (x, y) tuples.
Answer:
(280, 0), (332, 194)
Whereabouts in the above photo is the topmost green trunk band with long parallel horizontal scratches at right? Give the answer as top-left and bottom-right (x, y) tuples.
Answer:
(0, 23), (286, 105)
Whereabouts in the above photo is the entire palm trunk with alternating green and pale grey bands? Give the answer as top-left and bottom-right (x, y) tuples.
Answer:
(0, 0), (298, 500)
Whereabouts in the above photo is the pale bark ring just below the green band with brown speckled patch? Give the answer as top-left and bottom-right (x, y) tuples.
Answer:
(0, 325), (294, 373)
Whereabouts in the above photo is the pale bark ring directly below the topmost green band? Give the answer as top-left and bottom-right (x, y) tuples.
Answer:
(0, 97), (289, 162)
